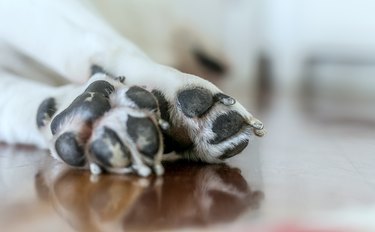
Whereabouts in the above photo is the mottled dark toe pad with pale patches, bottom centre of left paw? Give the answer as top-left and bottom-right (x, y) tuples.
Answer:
(90, 127), (130, 168)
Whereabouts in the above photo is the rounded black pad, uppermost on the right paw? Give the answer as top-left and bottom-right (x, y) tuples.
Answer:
(177, 88), (214, 118)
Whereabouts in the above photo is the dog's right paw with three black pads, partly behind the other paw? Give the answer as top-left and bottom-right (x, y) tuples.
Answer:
(148, 74), (265, 162)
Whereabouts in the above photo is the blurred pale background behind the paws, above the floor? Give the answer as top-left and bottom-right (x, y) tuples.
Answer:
(94, 0), (375, 119)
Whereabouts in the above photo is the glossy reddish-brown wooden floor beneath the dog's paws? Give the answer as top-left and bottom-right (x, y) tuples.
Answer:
(0, 88), (375, 232)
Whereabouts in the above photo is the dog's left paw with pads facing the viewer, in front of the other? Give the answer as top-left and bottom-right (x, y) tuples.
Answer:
(37, 74), (165, 176)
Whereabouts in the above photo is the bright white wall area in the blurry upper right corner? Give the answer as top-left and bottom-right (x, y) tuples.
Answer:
(260, 0), (375, 84)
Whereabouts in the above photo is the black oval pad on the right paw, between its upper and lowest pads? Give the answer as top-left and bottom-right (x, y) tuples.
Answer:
(210, 111), (245, 144)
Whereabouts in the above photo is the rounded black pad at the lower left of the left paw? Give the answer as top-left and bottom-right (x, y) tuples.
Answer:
(55, 132), (85, 167)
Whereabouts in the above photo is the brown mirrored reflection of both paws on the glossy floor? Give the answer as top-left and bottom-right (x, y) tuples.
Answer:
(35, 162), (263, 231)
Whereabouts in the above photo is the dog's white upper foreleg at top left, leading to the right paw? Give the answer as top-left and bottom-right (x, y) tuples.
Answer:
(0, 0), (147, 83)
